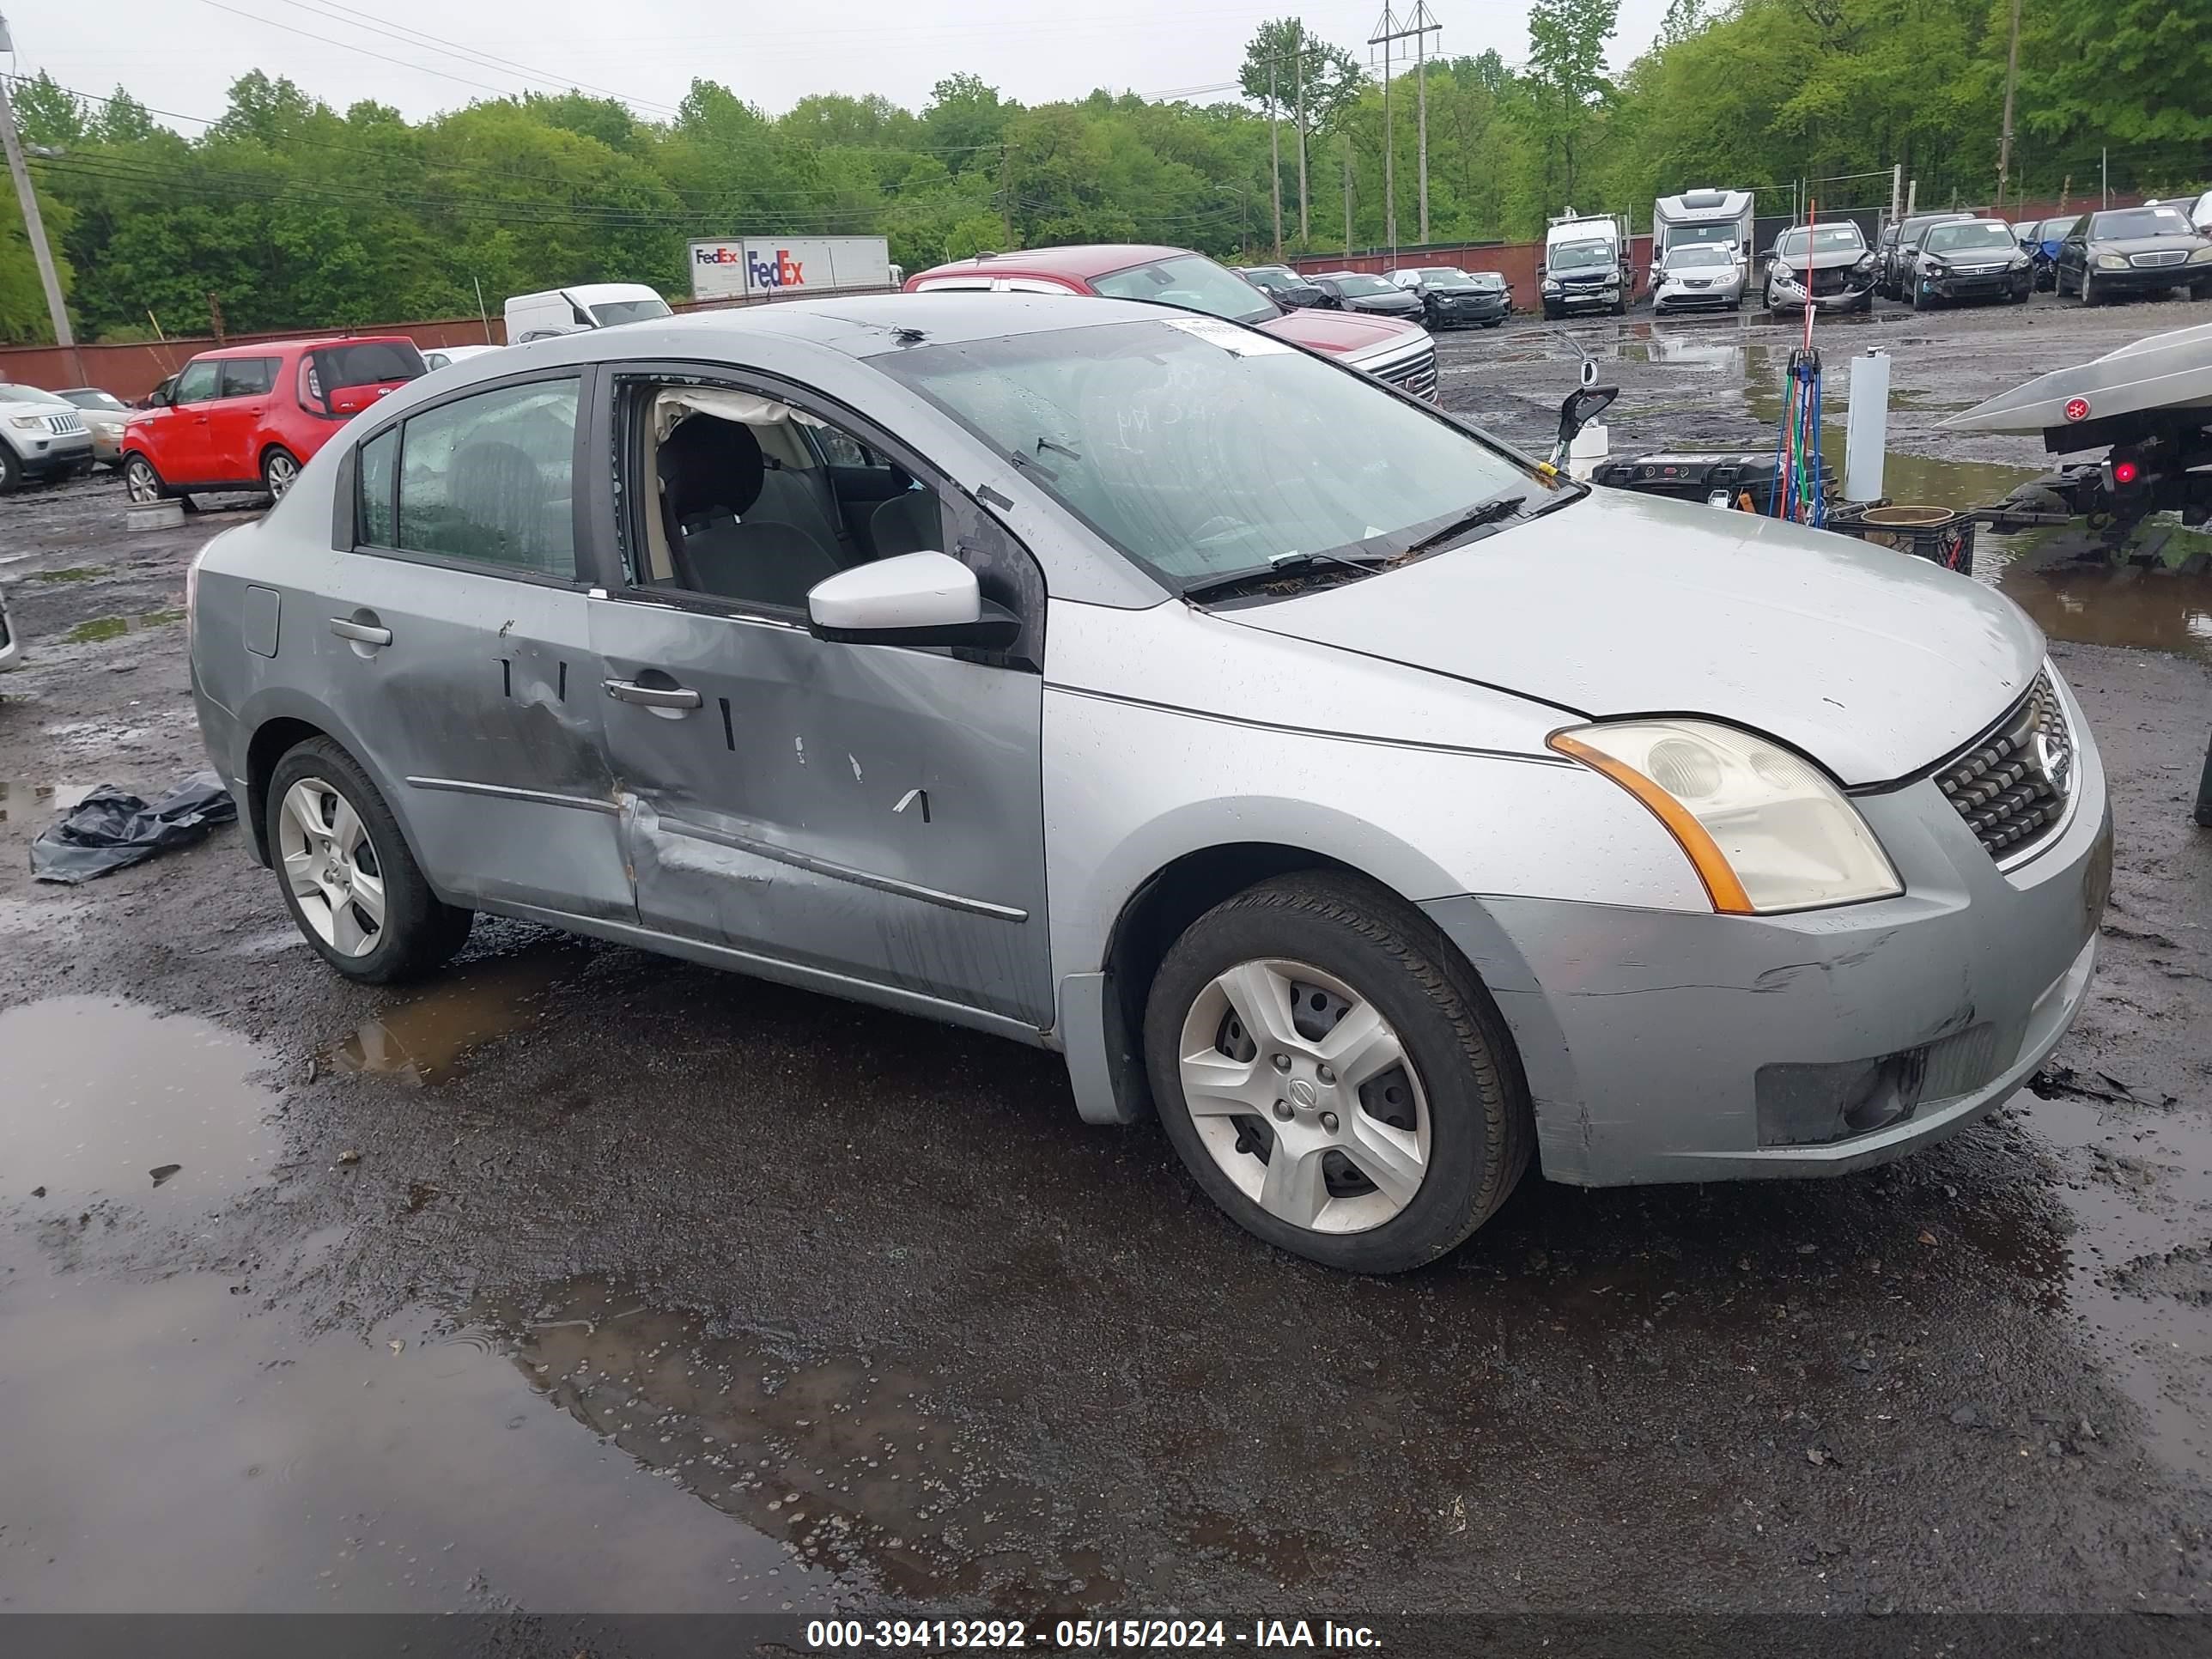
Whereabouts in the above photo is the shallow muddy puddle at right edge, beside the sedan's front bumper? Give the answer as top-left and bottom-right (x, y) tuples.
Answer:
(2008, 1091), (2212, 1478)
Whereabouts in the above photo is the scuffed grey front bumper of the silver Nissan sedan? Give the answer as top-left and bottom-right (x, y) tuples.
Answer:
(1422, 677), (2112, 1186)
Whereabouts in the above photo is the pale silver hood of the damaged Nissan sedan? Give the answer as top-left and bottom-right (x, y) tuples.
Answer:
(1218, 489), (2044, 785)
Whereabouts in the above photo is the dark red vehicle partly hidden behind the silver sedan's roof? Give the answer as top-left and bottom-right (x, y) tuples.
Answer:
(907, 243), (1436, 403)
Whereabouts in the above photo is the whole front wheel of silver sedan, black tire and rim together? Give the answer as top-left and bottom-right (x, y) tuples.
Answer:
(1144, 872), (1535, 1274)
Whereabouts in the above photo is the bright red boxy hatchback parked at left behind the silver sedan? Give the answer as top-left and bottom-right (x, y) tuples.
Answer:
(124, 334), (429, 502)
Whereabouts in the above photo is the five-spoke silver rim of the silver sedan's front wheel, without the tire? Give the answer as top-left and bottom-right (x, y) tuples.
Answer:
(1176, 957), (1429, 1232)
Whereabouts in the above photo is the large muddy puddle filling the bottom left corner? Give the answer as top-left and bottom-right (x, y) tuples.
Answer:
(0, 1256), (827, 1613)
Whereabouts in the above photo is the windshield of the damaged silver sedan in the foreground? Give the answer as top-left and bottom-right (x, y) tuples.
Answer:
(869, 319), (1541, 588)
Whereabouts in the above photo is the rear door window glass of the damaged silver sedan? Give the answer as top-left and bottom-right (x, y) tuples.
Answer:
(396, 380), (577, 581)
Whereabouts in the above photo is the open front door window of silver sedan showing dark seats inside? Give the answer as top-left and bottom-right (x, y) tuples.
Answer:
(633, 385), (945, 611)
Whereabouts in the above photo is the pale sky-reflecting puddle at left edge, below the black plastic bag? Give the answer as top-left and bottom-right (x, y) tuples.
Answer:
(0, 998), (270, 1210)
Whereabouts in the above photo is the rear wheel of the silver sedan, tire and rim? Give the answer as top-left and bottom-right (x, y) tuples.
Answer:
(264, 737), (476, 984)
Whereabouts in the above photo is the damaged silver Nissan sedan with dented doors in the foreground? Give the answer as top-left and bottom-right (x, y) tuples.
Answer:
(188, 295), (2111, 1272)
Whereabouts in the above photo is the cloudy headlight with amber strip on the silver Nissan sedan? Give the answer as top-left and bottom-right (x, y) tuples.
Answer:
(1551, 719), (1905, 915)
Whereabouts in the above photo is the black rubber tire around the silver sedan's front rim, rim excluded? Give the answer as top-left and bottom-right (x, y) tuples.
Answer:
(1144, 872), (1535, 1274)
